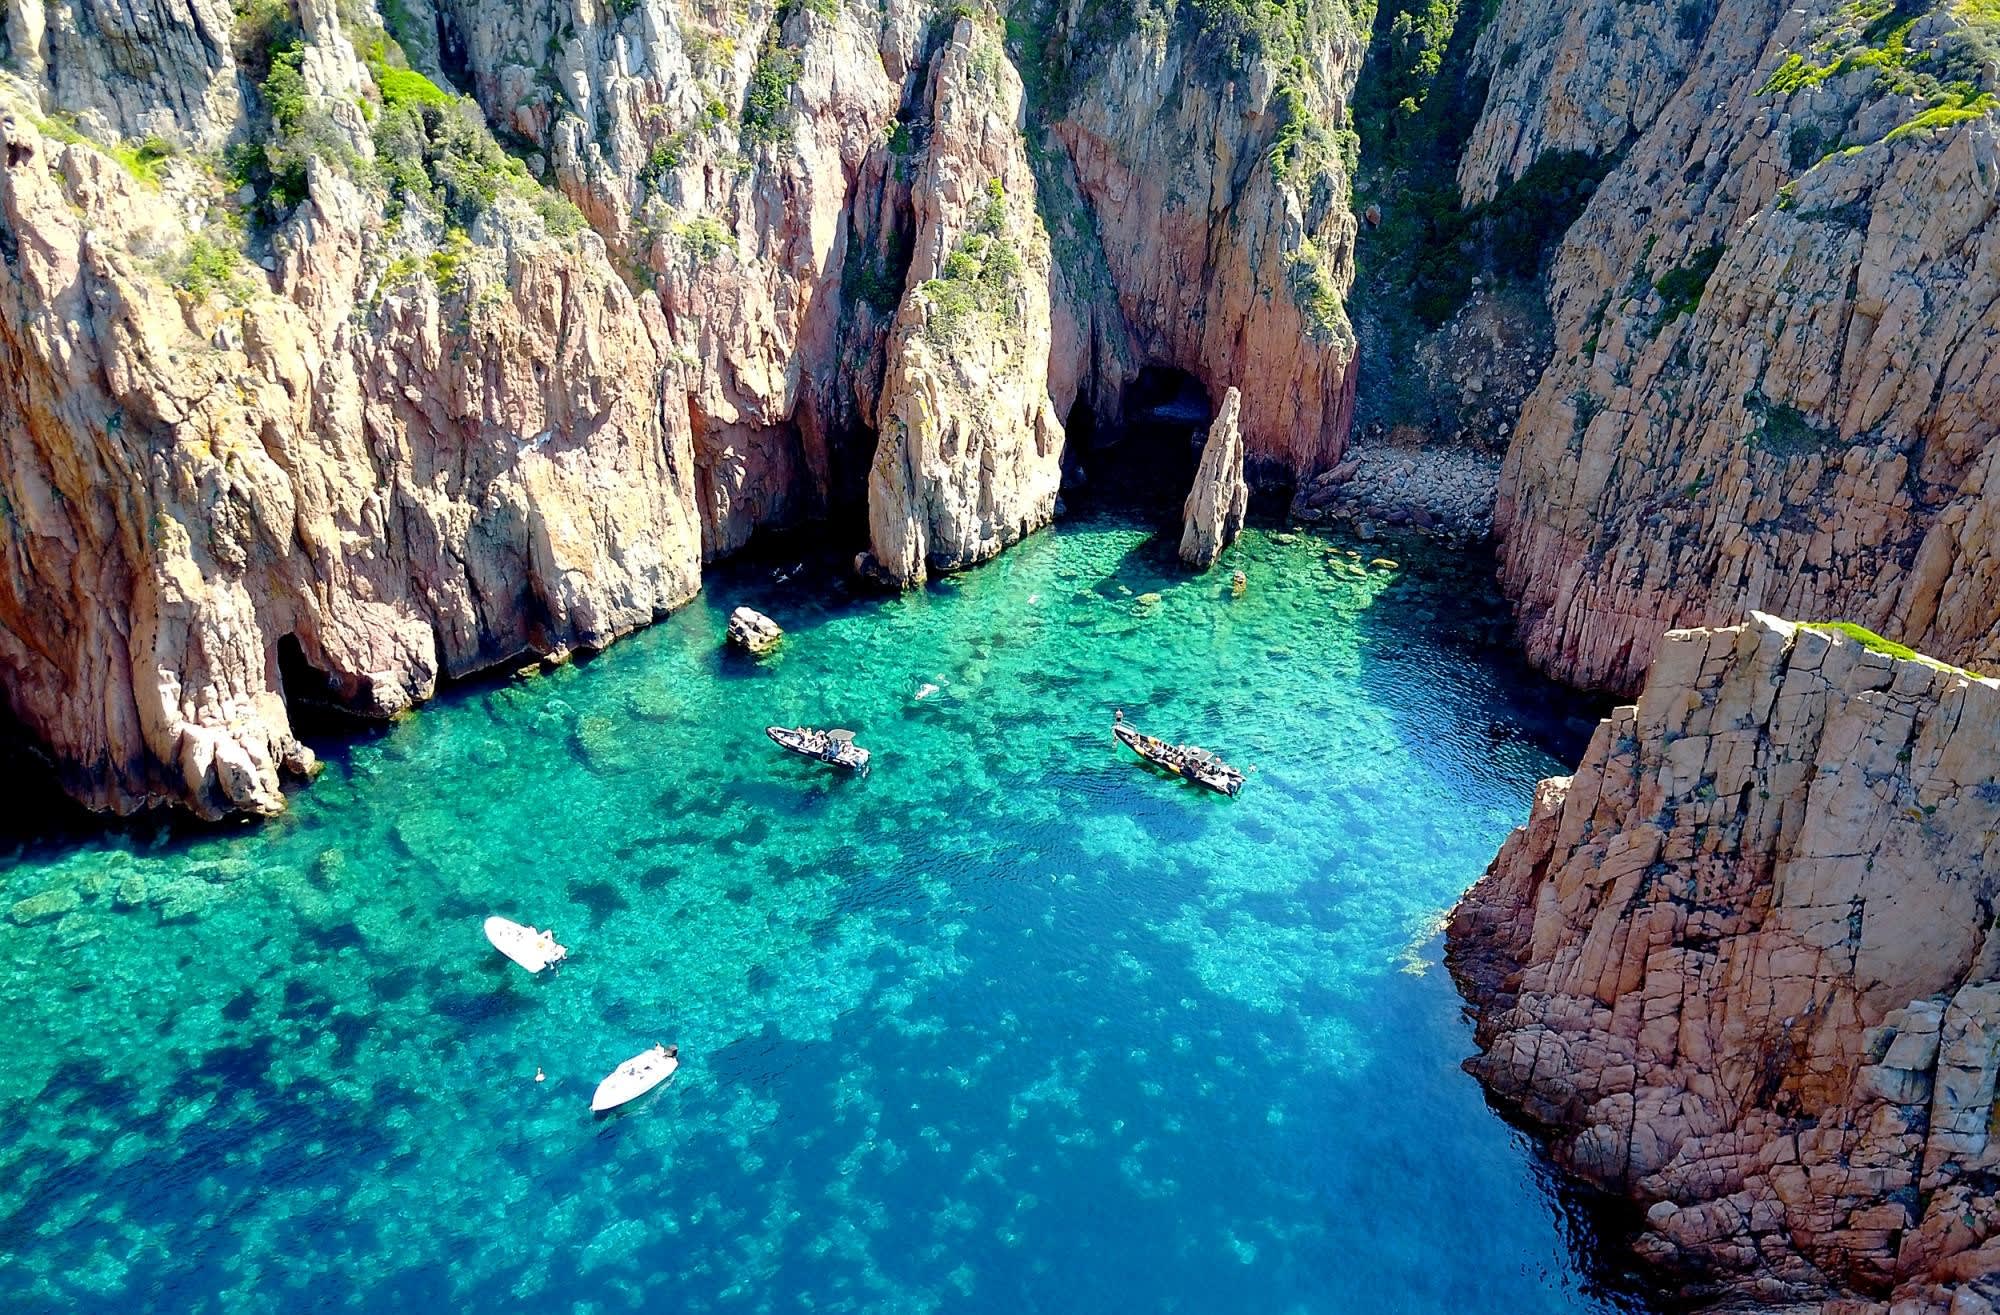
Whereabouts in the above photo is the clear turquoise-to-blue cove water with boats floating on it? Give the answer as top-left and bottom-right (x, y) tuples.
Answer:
(0, 518), (1628, 1315)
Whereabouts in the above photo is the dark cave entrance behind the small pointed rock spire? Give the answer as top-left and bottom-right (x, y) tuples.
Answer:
(1062, 366), (1214, 510)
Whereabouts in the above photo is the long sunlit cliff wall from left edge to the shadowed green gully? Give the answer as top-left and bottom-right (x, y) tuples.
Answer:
(0, 0), (1360, 815)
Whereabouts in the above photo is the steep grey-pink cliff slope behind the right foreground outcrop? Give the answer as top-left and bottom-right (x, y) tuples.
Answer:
(1460, 0), (2000, 689)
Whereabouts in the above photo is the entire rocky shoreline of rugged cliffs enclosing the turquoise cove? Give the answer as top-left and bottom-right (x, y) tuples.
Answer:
(11, 0), (2000, 1315)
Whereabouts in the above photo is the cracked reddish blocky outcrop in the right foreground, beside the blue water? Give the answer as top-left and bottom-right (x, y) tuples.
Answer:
(1448, 614), (2000, 1315)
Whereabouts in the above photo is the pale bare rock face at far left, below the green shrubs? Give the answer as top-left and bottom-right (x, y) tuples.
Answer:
(0, 97), (698, 815)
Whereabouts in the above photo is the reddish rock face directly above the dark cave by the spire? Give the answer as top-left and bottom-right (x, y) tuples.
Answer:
(1054, 16), (1362, 484)
